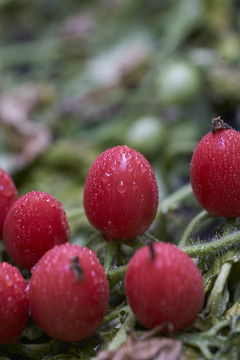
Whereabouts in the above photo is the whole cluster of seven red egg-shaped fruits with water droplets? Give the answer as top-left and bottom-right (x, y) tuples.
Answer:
(0, 118), (240, 345)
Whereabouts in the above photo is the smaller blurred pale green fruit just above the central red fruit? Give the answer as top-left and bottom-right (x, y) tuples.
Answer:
(125, 115), (166, 154)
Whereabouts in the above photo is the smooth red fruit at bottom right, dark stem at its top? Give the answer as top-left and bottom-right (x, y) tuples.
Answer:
(125, 242), (204, 332)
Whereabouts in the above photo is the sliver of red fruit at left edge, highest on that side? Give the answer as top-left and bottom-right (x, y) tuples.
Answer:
(0, 168), (18, 239)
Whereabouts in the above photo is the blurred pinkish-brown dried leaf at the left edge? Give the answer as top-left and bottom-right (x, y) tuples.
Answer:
(0, 84), (52, 170)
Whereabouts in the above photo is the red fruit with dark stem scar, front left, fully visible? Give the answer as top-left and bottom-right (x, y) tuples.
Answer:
(29, 243), (109, 342)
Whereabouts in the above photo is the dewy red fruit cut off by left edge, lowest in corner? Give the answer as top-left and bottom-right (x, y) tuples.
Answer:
(0, 262), (29, 345)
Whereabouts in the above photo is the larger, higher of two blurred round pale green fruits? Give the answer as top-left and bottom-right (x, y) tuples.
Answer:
(156, 61), (201, 105)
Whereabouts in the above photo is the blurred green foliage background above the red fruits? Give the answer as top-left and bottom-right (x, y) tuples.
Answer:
(0, 0), (240, 225)
